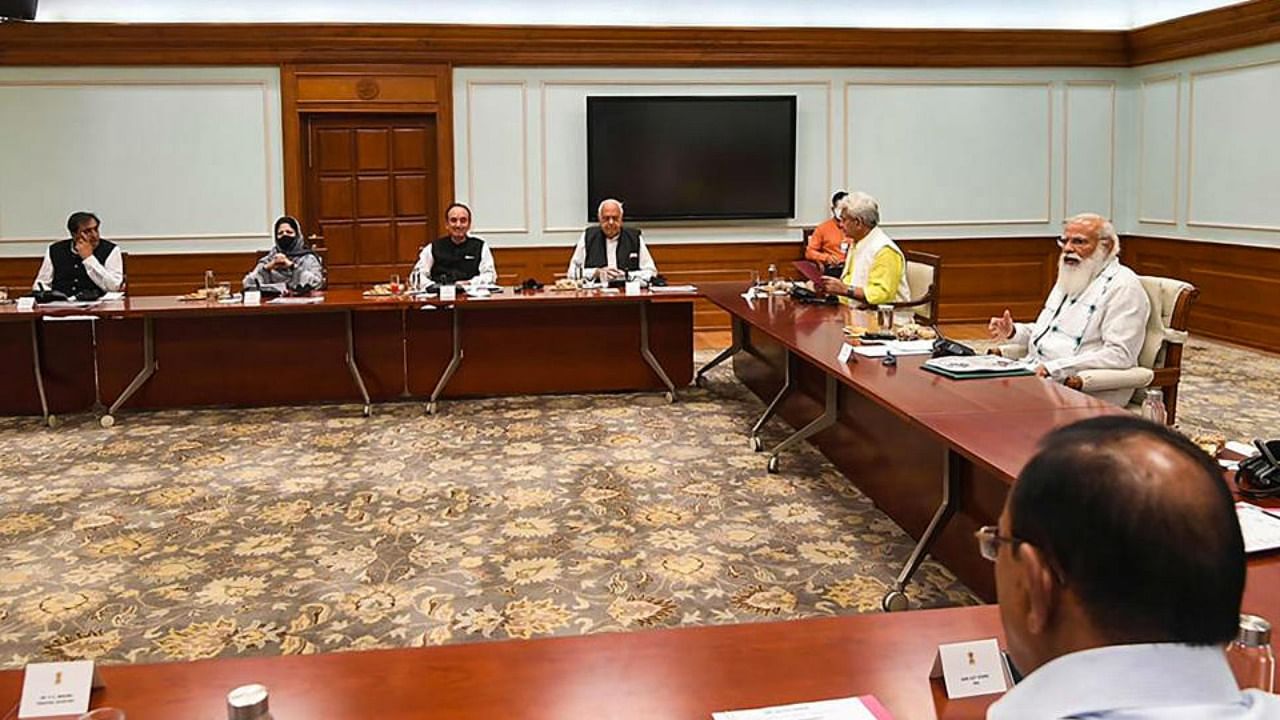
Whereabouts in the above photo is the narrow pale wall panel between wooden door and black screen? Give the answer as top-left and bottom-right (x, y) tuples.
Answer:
(463, 82), (529, 234)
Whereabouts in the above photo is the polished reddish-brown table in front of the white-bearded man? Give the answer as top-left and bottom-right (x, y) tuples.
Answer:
(698, 283), (1124, 609)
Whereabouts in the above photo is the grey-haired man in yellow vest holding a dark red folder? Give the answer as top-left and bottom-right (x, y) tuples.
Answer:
(820, 192), (911, 305)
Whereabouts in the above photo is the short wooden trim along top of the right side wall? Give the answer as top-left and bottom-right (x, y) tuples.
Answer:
(1128, 0), (1280, 65)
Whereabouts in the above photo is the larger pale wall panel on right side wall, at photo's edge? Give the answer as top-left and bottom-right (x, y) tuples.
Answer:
(1187, 63), (1280, 231)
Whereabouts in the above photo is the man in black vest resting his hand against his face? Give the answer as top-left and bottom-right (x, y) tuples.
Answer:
(32, 211), (124, 300)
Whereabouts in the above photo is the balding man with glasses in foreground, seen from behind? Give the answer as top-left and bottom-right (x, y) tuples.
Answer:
(978, 415), (1280, 720)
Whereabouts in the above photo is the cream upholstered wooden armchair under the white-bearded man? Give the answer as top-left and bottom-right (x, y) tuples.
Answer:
(1000, 275), (1199, 424)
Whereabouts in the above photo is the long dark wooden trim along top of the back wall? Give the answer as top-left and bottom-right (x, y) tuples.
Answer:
(0, 23), (1129, 68)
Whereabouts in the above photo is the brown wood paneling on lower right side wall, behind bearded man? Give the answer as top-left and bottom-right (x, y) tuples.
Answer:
(1121, 236), (1280, 352)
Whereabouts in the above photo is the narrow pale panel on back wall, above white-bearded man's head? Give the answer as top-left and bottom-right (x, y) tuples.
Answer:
(1062, 82), (1116, 218)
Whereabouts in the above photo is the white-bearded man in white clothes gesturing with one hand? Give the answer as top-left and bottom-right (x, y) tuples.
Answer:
(987, 213), (1151, 406)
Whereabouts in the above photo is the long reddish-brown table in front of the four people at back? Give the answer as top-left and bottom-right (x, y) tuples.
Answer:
(0, 288), (696, 425)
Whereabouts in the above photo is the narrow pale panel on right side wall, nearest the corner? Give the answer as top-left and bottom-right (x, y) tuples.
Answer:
(1138, 74), (1181, 225)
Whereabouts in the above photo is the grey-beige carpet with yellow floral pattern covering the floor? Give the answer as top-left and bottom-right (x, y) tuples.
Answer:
(0, 340), (1280, 667)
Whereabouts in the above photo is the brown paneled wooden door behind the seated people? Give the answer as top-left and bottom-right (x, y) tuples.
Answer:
(306, 114), (439, 286)
